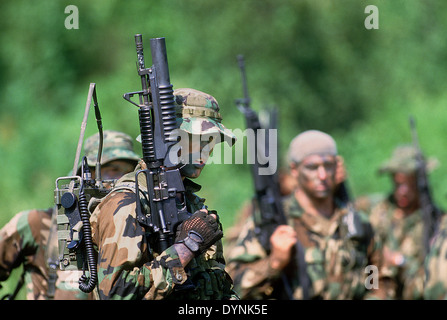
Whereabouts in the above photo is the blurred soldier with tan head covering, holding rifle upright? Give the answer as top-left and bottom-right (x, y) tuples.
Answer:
(228, 130), (393, 299)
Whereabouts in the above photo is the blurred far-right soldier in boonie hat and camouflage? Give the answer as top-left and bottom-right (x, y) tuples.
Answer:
(368, 145), (437, 300)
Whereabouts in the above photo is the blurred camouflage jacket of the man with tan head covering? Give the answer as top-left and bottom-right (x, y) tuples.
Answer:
(228, 195), (394, 300)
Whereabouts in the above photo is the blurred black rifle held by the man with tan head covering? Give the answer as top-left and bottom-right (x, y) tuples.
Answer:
(235, 55), (310, 300)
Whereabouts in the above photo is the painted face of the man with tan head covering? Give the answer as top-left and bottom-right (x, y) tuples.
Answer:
(295, 155), (337, 199)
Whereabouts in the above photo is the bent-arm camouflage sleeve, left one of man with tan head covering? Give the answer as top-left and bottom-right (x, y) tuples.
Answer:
(227, 220), (280, 299)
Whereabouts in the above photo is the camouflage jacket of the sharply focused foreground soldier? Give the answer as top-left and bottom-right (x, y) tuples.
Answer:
(91, 167), (237, 300)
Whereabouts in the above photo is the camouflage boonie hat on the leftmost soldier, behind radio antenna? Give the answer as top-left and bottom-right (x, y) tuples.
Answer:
(84, 130), (140, 166)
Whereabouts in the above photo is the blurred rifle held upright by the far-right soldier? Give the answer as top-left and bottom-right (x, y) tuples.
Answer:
(410, 116), (442, 255)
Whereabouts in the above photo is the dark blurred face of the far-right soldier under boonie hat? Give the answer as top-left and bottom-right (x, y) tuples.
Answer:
(392, 172), (419, 209)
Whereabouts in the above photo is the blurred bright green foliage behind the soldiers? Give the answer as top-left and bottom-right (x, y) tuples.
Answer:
(0, 0), (447, 297)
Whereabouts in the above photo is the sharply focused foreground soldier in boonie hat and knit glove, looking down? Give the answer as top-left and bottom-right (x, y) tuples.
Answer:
(90, 89), (240, 300)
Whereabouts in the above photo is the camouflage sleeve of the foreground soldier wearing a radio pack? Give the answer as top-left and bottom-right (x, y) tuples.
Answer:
(91, 192), (187, 299)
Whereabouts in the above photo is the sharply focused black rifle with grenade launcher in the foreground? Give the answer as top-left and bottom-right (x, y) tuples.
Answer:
(123, 34), (189, 253)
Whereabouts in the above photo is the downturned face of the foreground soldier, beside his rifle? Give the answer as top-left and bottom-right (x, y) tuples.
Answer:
(180, 135), (215, 179)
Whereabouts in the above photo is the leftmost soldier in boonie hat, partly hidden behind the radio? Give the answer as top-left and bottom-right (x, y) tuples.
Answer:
(0, 130), (139, 300)
